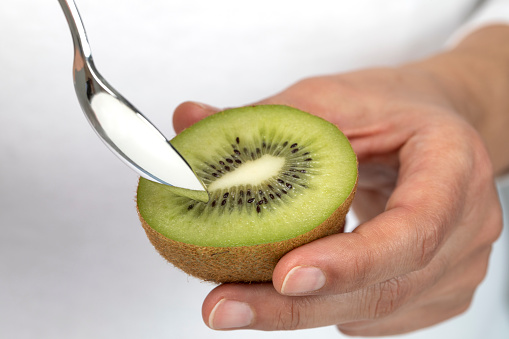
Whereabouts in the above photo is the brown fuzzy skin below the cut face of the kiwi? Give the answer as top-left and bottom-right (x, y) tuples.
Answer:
(138, 183), (357, 283)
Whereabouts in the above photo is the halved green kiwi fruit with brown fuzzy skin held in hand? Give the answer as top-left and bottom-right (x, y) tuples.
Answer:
(137, 105), (357, 283)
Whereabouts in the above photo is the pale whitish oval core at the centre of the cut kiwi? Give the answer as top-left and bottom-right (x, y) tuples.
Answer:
(207, 154), (285, 191)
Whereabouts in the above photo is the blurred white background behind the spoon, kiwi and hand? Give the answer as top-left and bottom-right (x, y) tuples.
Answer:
(0, 0), (509, 339)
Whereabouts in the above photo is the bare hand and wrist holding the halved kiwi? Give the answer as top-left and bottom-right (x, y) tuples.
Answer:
(174, 26), (509, 336)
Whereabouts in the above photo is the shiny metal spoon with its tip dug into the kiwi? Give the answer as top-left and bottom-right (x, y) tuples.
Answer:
(58, 0), (208, 201)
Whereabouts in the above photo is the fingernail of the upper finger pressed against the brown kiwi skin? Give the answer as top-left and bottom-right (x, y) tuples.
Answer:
(281, 266), (326, 294)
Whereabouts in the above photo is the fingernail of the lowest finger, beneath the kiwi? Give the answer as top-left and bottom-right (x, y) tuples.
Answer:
(209, 299), (254, 330)
